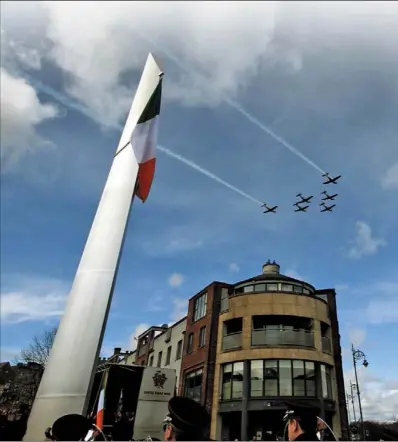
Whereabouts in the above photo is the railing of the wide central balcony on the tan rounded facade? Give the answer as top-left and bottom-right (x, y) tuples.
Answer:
(252, 329), (315, 347)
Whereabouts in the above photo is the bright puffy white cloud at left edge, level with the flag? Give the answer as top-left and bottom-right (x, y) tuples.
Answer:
(0, 68), (58, 169)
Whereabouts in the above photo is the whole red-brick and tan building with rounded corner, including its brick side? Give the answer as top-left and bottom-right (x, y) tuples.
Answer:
(129, 262), (348, 440)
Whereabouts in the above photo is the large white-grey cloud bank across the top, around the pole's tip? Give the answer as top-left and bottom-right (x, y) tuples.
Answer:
(3, 1), (398, 126)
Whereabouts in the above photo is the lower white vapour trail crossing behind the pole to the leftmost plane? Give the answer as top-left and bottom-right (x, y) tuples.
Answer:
(25, 75), (263, 205)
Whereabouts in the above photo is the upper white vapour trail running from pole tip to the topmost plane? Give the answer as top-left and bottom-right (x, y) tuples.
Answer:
(137, 32), (326, 174)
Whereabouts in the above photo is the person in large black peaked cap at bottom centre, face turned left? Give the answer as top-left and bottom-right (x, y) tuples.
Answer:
(163, 396), (210, 441)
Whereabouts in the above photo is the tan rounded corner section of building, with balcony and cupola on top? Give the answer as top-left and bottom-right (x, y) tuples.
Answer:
(211, 262), (346, 440)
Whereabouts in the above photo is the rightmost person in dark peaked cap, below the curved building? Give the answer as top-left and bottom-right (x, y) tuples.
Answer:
(283, 402), (319, 441)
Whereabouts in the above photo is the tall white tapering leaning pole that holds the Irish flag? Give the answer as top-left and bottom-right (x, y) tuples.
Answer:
(24, 54), (162, 441)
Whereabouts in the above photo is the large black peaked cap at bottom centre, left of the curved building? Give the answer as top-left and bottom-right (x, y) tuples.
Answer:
(168, 396), (210, 433)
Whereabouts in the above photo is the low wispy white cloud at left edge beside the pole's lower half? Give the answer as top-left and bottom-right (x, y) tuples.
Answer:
(0, 275), (67, 324)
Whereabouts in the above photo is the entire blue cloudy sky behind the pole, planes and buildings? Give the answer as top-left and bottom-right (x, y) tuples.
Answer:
(0, 1), (398, 420)
